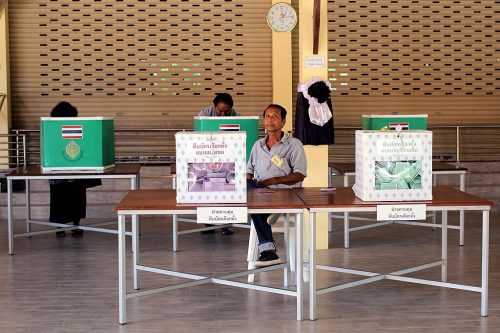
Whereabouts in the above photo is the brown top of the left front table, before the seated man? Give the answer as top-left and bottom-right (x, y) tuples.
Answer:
(114, 188), (305, 211)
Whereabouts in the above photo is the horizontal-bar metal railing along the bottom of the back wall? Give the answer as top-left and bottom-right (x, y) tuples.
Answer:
(11, 125), (500, 164)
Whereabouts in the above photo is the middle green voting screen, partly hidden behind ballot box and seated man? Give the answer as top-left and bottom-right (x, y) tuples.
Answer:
(194, 116), (259, 161)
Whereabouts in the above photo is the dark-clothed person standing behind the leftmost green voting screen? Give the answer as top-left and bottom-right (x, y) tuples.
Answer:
(49, 102), (102, 237)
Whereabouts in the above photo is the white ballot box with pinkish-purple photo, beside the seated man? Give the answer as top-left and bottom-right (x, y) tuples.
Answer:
(175, 132), (247, 204)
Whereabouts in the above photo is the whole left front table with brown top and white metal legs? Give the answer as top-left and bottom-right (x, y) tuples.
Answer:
(115, 188), (305, 324)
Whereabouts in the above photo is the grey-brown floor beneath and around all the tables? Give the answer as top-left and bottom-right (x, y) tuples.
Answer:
(0, 213), (500, 333)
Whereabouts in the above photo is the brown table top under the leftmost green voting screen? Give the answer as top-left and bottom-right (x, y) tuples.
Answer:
(7, 163), (141, 178)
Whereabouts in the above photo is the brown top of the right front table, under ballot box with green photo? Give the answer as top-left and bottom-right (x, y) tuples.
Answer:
(294, 186), (493, 208)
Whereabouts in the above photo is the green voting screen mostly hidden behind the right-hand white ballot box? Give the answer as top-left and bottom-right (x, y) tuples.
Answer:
(361, 114), (427, 131)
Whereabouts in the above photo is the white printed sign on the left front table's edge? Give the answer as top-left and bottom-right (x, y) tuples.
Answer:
(196, 207), (248, 224)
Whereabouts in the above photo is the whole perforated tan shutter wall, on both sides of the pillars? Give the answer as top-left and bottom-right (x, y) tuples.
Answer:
(9, 0), (500, 160)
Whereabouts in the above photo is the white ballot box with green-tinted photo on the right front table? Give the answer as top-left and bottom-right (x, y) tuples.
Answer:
(353, 130), (432, 201)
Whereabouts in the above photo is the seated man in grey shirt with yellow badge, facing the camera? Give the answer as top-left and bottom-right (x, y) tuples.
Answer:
(247, 104), (307, 267)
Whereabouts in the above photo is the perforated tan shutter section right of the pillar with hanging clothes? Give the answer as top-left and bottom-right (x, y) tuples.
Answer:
(328, 0), (500, 126)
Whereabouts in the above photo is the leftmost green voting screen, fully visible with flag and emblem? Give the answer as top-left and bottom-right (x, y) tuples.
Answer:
(40, 117), (115, 173)
